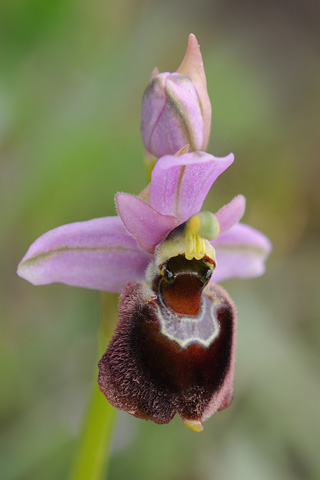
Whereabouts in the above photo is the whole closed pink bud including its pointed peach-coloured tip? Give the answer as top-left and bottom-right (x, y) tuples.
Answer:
(141, 34), (211, 158)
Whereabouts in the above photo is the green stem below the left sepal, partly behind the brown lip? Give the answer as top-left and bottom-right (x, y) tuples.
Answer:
(69, 292), (117, 480)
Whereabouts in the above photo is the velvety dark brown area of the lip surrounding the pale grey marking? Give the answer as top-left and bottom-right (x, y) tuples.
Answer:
(99, 282), (233, 424)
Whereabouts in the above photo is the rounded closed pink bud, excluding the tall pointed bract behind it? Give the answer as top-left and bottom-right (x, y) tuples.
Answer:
(141, 73), (203, 157)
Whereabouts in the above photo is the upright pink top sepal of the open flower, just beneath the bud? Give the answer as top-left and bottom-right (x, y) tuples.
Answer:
(149, 152), (234, 223)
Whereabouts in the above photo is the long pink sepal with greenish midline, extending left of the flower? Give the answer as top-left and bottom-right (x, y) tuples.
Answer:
(17, 217), (151, 292)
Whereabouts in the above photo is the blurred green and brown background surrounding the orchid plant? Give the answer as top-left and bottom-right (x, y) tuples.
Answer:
(0, 0), (320, 480)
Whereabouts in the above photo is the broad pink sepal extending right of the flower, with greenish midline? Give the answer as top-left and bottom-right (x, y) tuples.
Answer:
(211, 223), (272, 282)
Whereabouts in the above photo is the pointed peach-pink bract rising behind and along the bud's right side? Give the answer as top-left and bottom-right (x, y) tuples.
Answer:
(177, 33), (211, 150)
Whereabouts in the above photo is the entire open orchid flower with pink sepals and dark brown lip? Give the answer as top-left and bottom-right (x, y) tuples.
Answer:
(18, 152), (271, 431)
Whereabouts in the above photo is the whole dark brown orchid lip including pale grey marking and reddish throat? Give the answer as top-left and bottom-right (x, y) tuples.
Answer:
(98, 257), (236, 430)
